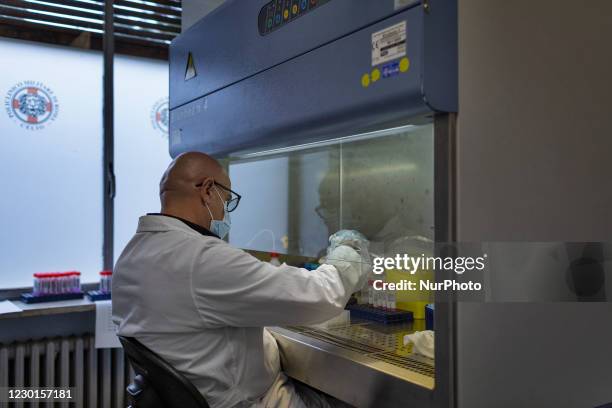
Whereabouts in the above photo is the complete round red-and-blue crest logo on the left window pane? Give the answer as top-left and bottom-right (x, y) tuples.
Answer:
(4, 81), (59, 130)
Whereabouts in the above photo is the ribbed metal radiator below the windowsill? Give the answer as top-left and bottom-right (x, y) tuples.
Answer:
(0, 335), (133, 408)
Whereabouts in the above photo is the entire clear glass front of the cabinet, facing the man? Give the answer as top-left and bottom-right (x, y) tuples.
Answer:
(229, 125), (434, 257)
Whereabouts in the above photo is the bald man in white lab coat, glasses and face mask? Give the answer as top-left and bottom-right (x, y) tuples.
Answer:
(113, 152), (367, 408)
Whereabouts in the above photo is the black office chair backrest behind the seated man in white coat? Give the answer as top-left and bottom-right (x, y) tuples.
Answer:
(118, 336), (209, 408)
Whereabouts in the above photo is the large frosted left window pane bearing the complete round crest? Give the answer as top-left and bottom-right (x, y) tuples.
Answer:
(0, 38), (103, 288)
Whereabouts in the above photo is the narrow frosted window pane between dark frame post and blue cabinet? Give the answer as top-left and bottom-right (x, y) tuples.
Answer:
(114, 55), (171, 260)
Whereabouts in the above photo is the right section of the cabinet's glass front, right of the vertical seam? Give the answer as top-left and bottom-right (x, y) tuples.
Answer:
(338, 125), (434, 256)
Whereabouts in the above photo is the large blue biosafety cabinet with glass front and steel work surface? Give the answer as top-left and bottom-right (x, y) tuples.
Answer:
(169, 0), (457, 407)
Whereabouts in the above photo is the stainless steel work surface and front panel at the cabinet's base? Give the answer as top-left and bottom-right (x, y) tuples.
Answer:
(270, 320), (435, 407)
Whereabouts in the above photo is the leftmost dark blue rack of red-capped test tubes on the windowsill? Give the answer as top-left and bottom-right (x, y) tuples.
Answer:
(21, 271), (83, 303)
